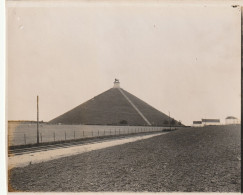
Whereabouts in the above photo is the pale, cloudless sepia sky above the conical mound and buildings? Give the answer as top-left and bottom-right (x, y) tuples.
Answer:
(6, 1), (241, 125)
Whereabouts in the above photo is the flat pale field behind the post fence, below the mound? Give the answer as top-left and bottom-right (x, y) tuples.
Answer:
(8, 123), (169, 146)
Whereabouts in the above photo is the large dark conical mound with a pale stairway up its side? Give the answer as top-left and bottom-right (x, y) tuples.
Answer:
(49, 80), (177, 126)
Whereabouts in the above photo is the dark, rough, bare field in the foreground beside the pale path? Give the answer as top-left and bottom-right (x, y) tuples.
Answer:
(9, 126), (241, 192)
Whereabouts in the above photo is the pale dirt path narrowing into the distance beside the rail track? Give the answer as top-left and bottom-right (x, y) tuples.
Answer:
(8, 132), (167, 169)
